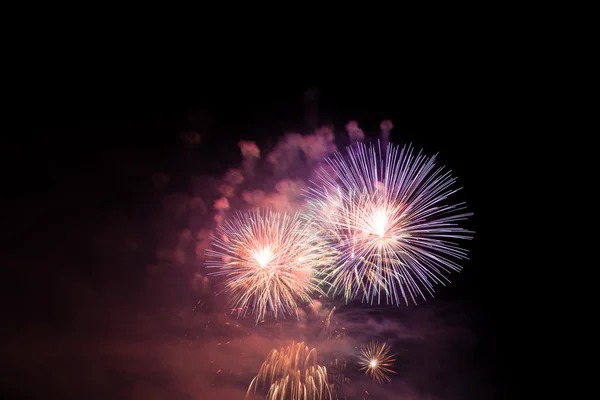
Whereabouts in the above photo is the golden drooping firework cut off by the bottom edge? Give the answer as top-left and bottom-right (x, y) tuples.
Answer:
(246, 343), (333, 400)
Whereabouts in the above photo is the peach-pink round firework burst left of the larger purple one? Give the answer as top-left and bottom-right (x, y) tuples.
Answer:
(207, 211), (332, 323)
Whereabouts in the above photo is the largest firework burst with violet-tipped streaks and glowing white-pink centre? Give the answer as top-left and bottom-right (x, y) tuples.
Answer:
(308, 144), (472, 305)
